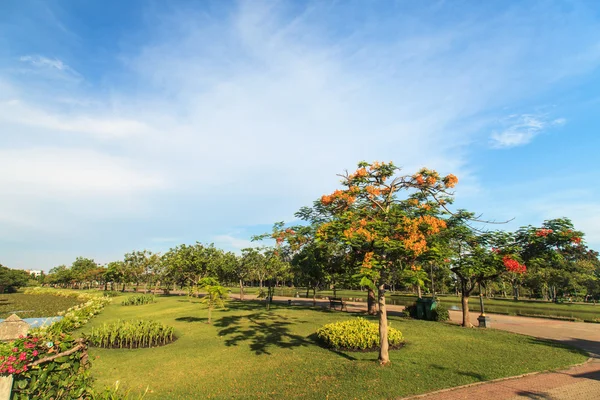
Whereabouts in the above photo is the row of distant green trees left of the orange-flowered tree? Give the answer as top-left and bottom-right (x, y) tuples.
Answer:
(42, 243), (293, 296)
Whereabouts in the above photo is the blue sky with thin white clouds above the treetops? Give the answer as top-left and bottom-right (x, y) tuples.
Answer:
(0, 0), (600, 269)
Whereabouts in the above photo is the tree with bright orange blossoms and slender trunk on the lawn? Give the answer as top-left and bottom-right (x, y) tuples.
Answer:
(316, 162), (458, 364)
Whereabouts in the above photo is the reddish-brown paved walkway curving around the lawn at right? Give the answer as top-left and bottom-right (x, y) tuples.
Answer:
(238, 295), (600, 400)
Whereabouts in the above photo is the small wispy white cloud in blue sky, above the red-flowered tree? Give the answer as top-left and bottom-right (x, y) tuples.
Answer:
(491, 114), (566, 149)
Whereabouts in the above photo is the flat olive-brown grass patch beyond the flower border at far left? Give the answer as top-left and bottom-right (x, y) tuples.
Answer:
(0, 293), (81, 318)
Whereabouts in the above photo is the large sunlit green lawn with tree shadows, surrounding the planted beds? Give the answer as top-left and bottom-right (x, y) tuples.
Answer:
(83, 296), (586, 399)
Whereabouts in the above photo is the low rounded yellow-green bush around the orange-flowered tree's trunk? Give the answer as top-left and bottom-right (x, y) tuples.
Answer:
(317, 317), (404, 351)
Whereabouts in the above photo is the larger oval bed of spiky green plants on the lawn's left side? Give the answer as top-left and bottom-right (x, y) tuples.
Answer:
(85, 320), (175, 349)
